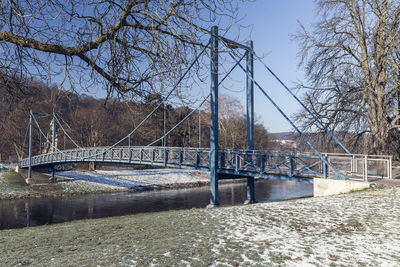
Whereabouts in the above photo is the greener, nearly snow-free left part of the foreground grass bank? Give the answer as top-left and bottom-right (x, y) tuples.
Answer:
(0, 210), (223, 266)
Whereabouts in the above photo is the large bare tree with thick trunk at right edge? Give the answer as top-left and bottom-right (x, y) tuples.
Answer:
(296, 0), (400, 156)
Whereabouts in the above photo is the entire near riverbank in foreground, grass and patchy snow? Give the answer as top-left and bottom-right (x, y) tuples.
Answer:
(0, 187), (400, 266)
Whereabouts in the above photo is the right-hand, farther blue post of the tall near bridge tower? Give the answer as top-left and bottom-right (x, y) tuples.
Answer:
(245, 41), (255, 203)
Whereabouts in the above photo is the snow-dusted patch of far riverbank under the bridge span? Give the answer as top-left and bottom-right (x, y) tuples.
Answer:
(57, 169), (209, 191)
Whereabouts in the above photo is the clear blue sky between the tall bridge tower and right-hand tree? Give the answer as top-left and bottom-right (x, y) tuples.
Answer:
(227, 0), (316, 132)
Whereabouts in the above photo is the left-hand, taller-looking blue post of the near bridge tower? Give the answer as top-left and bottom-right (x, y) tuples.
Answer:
(208, 26), (219, 207)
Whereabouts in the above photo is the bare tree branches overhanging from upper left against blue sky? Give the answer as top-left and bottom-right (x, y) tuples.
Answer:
(0, 0), (242, 97)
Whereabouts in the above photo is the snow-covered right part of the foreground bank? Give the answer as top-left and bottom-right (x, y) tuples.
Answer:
(208, 187), (400, 266)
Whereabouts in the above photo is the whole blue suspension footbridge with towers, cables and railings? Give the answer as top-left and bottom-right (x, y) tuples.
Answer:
(19, 26), (392, 206)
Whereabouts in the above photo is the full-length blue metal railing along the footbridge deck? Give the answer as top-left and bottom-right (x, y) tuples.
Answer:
(19, 147), (392, 180)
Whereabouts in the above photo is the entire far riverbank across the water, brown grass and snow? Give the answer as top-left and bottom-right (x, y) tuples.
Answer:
(0, 169), (209, 199)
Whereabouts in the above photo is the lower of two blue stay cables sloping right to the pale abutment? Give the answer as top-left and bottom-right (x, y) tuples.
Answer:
(229, 53), (346, 179)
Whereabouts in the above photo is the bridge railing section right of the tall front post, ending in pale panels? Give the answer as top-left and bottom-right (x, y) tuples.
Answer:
(219, 150), (392, 181)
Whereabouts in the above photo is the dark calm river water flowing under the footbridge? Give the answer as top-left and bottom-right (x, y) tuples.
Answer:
(0, 180), (313, 229)
